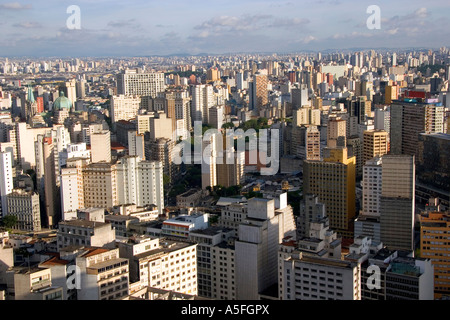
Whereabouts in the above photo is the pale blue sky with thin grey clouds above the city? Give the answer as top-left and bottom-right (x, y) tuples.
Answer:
(0, 0), (450, 57)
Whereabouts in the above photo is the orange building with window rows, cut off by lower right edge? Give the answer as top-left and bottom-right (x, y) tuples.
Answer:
(420, 211), (450, 298)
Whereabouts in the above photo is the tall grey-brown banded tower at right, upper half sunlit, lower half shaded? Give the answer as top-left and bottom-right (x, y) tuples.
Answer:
(380, 155), (415, 251)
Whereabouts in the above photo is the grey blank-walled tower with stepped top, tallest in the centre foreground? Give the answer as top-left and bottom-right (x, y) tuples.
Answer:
(235, 193), (295, 300)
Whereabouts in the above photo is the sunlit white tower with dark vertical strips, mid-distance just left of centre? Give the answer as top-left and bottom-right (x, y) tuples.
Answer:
(191, 84), (216, 123)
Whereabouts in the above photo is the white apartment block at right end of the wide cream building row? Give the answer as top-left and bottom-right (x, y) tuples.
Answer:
(116, 156), (164, 214)
